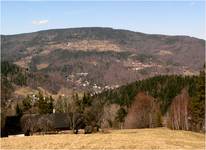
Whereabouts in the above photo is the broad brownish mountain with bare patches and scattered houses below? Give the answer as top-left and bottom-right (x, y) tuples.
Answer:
(1, 27), (205, 94)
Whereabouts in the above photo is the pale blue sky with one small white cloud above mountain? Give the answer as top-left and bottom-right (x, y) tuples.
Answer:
(1, 1), (206, 39)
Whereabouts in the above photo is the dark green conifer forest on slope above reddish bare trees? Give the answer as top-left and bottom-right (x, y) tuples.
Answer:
(97, 75), (198, 113)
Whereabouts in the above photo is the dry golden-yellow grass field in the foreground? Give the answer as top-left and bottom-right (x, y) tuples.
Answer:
(1, 128), (205, 150)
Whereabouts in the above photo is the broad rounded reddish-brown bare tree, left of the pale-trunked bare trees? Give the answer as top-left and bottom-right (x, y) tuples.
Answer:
(124, 92), (161, 128)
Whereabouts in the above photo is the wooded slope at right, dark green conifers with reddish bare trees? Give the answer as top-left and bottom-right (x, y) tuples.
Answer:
(91, 71), (205, 131)
